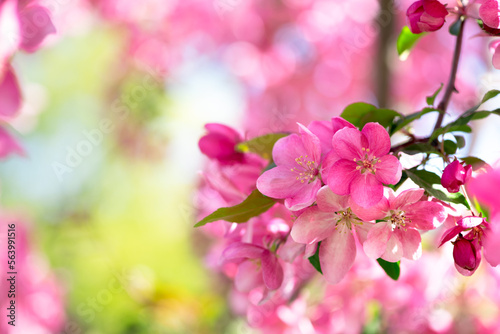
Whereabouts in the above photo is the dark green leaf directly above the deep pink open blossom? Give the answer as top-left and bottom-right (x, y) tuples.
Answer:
(340, 102), (402, 128)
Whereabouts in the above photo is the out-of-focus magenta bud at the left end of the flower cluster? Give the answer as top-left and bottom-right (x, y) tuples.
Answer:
(198, 123), (244, 164)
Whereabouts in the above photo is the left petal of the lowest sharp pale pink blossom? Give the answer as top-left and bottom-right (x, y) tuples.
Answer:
(290, 206), (336, 244)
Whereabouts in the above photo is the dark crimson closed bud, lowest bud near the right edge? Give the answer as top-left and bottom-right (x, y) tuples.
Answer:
(453, 234), (481, 276)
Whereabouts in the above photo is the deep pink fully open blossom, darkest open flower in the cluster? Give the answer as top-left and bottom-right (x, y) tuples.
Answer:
(326, 123), (401, 208)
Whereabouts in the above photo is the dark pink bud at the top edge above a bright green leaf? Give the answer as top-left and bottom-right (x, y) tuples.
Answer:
(406, 0), (448, 34)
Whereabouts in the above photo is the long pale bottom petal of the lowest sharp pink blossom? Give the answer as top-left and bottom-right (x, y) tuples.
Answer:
(319, 224), (356, 284)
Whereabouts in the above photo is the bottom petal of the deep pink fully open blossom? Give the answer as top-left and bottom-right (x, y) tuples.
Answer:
(350, 173), (384, 208)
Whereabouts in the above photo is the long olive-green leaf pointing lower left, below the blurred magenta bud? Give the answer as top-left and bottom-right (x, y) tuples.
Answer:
(194, 189), (276, 227)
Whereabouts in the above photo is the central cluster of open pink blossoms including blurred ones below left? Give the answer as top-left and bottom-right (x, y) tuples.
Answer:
(196, 117), (454, 333)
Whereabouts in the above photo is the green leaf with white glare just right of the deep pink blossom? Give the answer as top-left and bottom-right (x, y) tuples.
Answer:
(406, 168), (469, 208)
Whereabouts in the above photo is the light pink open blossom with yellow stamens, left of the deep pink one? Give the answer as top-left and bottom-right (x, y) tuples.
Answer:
(257, 124), (321, 211)
